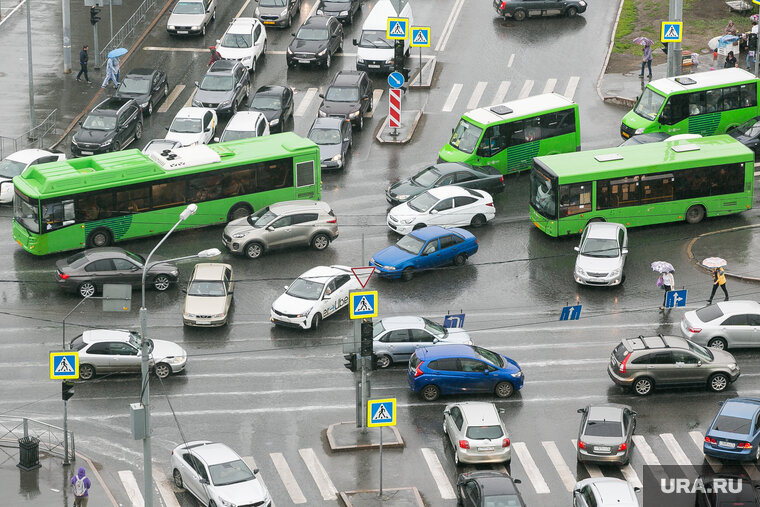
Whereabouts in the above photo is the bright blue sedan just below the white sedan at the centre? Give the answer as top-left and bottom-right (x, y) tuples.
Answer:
(369, 226), (478, 280)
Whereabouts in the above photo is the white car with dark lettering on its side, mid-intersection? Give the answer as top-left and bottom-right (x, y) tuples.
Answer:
(270, 266), (360, 329)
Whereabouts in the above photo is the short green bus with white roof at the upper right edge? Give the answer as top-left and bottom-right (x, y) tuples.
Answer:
(620, 68), (760, 139)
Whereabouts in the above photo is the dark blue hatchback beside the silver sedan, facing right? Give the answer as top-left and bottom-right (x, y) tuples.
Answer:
(407, 345), (525, 401)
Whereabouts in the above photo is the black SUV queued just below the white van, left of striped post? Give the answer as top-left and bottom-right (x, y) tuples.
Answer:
(319, 70), (372, 130)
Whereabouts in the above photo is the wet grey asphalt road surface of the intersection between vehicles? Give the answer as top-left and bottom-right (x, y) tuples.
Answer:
(0, 0), (760, 506)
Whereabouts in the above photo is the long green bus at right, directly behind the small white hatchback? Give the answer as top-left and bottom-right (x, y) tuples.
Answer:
(530, 135), (755, 236)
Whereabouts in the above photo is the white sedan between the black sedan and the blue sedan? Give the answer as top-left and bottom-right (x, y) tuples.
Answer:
(388, 186), (496, 234)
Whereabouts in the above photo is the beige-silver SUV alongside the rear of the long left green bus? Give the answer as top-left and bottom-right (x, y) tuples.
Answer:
(222, 200), (338, 259)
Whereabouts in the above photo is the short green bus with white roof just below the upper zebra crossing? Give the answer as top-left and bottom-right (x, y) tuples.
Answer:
(438, 93), (581, 174)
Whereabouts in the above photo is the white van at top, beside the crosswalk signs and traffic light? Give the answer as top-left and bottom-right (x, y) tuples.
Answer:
(354, 0), (414, 72)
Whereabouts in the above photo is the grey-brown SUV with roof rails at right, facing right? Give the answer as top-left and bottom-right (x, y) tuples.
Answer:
(607, 335), (740, 396)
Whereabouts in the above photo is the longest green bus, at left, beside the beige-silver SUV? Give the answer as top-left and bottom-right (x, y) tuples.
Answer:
(13, 132), (321, 255)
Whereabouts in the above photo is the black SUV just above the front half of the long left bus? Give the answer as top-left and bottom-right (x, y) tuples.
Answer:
(71, 97), (142, 157)
